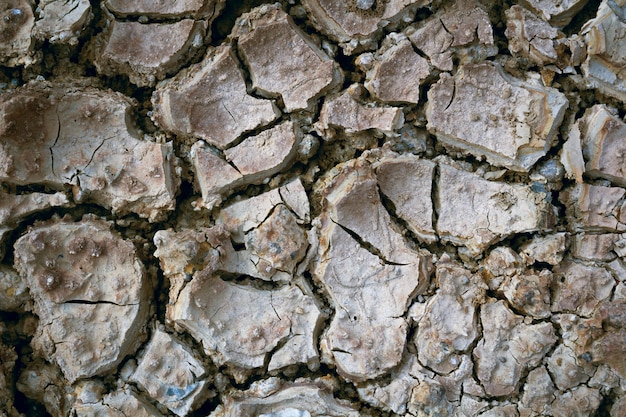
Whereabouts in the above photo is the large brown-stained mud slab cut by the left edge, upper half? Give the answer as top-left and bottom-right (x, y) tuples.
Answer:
(0, 82), (179, 221)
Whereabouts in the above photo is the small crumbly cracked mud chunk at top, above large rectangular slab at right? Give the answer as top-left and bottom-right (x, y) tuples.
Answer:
(407, 0), (498, 71)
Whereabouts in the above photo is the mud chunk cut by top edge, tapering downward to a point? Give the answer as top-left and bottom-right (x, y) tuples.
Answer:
(304, 0), (431, 50)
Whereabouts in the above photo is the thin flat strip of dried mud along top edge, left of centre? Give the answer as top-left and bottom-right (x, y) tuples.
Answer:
(104, 0), (219, 19)
